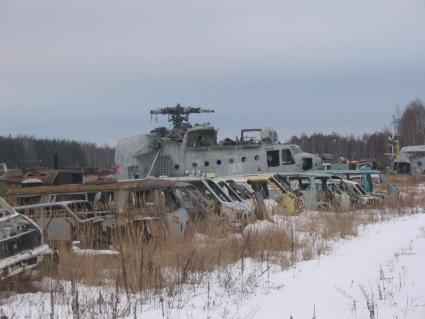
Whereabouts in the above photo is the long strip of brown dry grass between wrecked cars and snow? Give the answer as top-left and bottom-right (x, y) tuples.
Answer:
(49, 205), (404, 294)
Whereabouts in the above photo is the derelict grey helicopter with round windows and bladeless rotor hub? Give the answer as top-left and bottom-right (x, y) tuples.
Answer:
(115, 104), (322, 179)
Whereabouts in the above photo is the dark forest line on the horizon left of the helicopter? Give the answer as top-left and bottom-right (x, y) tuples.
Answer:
(0, 136), (115, 169)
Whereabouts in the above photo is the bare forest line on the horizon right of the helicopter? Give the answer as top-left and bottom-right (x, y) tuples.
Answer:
(289, 99), (425, 162)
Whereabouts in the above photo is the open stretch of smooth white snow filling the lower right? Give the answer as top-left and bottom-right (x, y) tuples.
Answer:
(144, 214), (425, 319)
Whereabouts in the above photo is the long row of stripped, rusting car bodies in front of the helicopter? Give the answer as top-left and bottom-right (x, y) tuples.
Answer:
(2, 170), (397, 252)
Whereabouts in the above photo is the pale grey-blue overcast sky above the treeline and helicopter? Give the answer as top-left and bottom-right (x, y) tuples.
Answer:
(0, 0), (425, 145)
